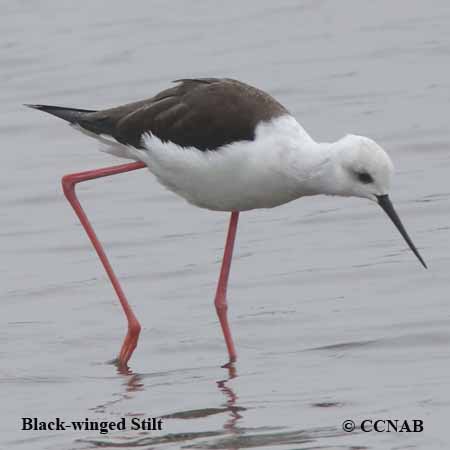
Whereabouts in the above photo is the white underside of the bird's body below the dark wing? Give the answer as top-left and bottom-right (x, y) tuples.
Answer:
(74, 115), (320, 211)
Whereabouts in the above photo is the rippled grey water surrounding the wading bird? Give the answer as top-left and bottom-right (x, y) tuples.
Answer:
(0, 0), (450, 450)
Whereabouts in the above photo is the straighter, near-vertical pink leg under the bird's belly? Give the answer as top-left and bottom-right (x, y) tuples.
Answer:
(214, 211), (239, 363)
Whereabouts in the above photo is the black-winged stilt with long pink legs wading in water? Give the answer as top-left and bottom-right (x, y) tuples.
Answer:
(25, 78), (427, 367)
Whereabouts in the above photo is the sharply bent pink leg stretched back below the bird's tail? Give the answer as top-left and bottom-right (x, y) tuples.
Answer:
(62, 162), (146, 367)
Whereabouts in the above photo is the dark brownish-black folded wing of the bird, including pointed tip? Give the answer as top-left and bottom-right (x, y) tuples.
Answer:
(30, 78), (288, 150)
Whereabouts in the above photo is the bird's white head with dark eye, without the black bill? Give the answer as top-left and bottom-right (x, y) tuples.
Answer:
(332, 135), (394, 201)
